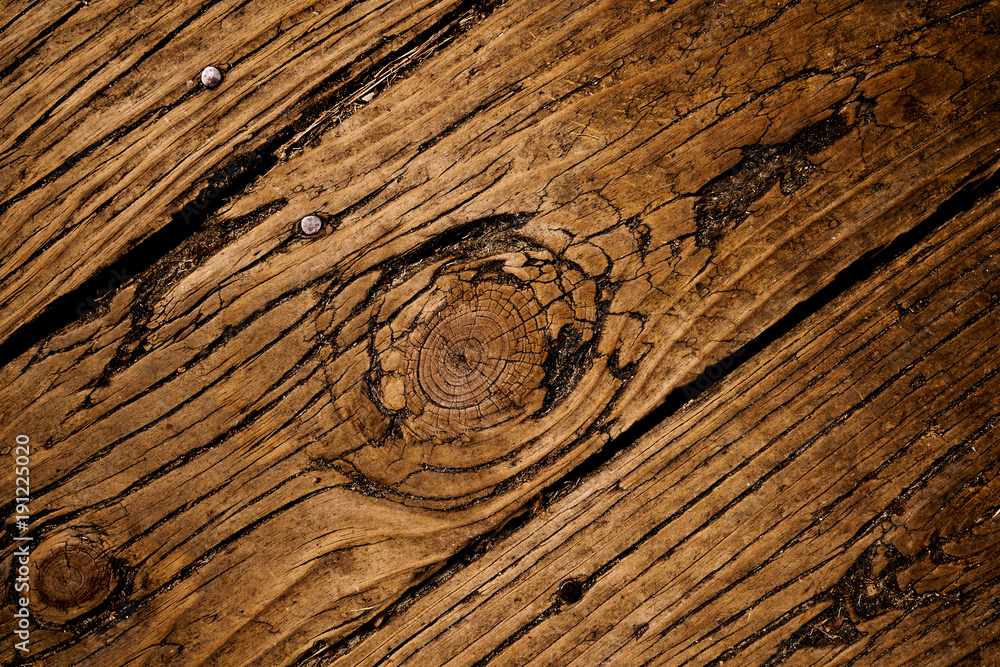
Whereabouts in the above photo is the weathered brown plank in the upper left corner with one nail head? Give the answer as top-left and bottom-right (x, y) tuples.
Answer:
(0, 0), (474, 350)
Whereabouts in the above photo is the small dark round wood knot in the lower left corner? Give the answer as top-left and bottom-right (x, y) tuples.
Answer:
(34, 544), (111, 615)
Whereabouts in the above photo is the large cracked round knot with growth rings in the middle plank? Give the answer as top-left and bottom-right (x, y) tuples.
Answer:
(320, 239), (601, 507)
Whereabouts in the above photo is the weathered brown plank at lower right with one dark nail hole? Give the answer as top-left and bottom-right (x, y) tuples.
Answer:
(320, 185), (1000, 667)
